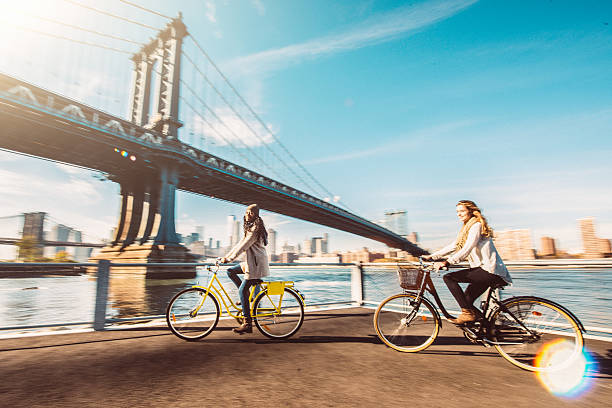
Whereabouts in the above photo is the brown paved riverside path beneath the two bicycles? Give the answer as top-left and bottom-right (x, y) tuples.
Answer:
(0, 308), (612, 408)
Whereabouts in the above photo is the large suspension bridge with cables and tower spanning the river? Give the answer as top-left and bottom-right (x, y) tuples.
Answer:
(0, 0), (424, 268)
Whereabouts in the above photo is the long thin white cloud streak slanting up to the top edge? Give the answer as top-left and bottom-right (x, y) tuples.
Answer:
(231, 0), (476, 72)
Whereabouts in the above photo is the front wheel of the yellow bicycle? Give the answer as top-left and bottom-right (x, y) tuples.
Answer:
(166, 288), (221, 341)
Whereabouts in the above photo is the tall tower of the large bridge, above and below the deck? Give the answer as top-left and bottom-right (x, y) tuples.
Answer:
(95, 14), (195, 276)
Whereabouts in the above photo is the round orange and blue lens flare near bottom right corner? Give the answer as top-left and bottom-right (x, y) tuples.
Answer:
(535, 339), (594, 398)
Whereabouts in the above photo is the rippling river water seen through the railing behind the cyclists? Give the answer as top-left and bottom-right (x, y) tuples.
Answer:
(0, 266), (612, 329)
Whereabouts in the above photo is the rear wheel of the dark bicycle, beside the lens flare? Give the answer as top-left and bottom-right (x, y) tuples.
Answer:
(490, 297), (584, 371)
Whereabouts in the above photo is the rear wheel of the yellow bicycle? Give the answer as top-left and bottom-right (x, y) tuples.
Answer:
(253, 288), (304, 339)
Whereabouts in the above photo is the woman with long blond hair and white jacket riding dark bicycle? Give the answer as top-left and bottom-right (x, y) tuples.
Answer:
(422, 200), (512, 324)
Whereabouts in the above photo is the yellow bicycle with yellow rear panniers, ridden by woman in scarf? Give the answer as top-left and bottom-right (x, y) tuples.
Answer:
(166, 265), (304, 341)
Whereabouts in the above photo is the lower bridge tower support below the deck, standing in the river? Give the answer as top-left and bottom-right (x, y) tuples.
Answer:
(92, 165), (196, 278)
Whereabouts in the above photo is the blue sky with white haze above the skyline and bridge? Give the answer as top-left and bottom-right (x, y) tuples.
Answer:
(0, 0), (612, 258)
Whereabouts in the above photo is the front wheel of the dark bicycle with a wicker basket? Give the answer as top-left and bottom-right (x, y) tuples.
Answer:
(374, 292), (440, 353)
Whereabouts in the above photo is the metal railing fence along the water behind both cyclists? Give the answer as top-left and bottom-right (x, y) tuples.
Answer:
(0, 263), (612, 338)
